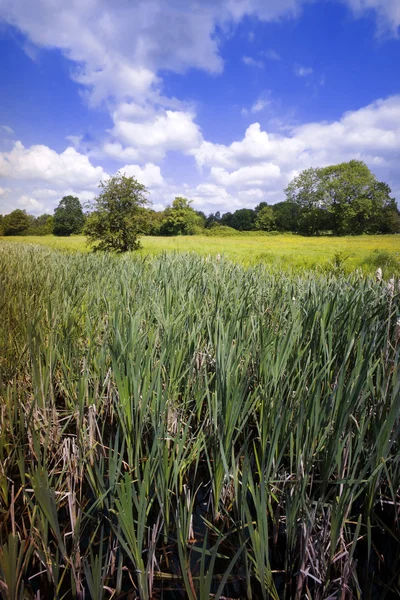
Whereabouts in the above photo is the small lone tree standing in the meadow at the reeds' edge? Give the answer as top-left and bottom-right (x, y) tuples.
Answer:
(84, 175), (149, 253)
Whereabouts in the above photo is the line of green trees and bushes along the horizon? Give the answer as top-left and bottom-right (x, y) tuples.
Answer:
(0, 160), (400, 243)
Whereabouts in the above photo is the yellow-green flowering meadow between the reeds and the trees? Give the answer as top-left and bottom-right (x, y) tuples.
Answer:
(0, 234), (400, 277)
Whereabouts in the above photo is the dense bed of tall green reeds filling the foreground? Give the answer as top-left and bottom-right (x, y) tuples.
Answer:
(0, 244), (400, 600)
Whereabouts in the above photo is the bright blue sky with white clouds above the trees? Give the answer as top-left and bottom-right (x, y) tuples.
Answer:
(0, 0), (400, 215)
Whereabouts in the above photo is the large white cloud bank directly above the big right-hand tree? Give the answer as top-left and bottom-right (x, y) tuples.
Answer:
(194, 95), (400, 205)
